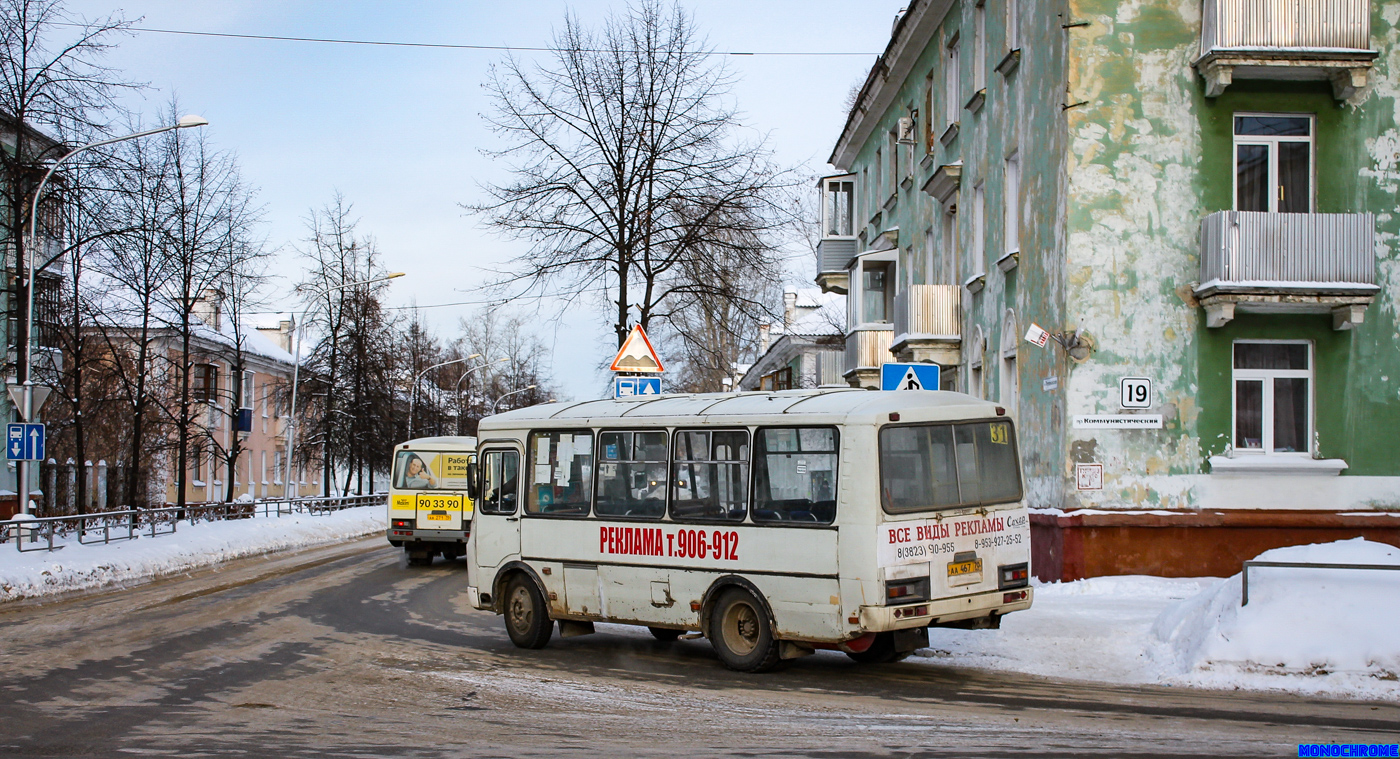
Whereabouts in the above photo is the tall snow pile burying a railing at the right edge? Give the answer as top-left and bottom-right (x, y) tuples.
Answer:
(1152, 538), (1400, 693)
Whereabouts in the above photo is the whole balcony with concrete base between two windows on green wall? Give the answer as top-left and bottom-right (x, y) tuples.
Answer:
(1196, 211), (1380, 329)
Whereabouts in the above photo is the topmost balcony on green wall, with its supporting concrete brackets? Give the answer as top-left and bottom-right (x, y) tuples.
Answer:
(1194, 0), (1378, 101)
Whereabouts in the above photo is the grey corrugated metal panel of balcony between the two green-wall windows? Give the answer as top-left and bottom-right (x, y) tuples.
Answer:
(1198, 211), (1376, 291)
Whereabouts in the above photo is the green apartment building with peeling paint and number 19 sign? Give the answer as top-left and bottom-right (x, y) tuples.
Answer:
(816, 0), (1400, 577)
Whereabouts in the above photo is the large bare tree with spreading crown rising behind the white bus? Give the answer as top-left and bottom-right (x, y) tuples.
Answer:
(468, 0), (792, 346)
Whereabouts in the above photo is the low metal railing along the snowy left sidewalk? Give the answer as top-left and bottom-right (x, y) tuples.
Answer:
(0, 493), (388, 552)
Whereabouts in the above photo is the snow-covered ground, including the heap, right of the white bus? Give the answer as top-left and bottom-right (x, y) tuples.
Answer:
(911, 538), (1400, 700)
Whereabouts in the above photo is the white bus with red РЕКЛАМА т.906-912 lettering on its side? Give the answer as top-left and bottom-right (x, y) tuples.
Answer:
(468, 389), (1032, 671)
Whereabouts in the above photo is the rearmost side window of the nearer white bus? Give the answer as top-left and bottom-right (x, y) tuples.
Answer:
(753, 427), (836, 524)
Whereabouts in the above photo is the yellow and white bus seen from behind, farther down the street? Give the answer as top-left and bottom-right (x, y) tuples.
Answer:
(388, 437), (476, 564)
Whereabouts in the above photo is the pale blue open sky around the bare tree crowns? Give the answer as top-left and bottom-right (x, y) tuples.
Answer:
(60, 0), (902, 398)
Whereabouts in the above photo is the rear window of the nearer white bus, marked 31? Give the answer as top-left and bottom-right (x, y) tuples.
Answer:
(879, 422), (1021, 514)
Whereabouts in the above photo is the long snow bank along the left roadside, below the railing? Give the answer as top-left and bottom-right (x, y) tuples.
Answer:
(0, 506), (384, 602)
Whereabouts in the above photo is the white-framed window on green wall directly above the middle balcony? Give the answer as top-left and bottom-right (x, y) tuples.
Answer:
(1235, 113), (1313, 213)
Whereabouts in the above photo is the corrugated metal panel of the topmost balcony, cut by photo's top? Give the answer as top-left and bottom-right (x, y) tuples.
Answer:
(1201, 0), (1371, 55)
